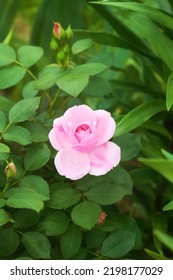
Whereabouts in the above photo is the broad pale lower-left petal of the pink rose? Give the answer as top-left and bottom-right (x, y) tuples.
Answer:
(55, 148), (90, 180)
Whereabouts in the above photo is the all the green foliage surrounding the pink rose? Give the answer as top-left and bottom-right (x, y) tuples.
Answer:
(0, 0), (173, 260)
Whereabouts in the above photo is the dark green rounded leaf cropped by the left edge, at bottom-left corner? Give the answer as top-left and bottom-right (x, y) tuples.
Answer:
(0, 228), (19, 257)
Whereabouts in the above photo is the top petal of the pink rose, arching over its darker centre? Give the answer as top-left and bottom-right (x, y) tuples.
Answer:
(63, 105), (97, 134)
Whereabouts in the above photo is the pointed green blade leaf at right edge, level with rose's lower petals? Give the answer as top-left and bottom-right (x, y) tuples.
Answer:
(138, 158), (173, 183)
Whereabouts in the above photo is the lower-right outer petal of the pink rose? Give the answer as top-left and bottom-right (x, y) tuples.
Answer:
(88, 142), (121, 176)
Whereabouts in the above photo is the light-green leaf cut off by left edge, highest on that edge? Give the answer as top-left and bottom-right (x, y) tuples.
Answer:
(0, 44), (16, 66)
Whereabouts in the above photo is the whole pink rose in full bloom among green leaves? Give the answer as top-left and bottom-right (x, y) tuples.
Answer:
(49, 105), (120, 180)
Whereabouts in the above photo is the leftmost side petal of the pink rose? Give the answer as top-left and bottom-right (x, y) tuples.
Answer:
(49, 117), (72, 151)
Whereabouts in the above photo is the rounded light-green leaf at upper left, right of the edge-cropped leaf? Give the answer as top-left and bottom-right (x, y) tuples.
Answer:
(17, 45), (43, 67)
